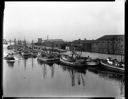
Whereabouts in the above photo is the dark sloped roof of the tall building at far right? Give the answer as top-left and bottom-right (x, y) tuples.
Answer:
(96, 35), (124, 41)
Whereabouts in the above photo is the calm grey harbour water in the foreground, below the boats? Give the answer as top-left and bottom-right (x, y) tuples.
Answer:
(3, 44), (125, 97)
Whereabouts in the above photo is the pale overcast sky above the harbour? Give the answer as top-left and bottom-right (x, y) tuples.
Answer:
(3, 0), (125, 41)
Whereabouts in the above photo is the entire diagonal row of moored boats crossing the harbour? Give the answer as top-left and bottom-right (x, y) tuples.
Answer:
(5, 47), (125, 72)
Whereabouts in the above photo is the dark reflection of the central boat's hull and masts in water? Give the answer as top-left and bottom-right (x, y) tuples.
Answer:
(60, 65), (87, 87)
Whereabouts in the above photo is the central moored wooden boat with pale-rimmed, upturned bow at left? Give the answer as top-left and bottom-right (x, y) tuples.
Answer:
(60, 55), (86, 68)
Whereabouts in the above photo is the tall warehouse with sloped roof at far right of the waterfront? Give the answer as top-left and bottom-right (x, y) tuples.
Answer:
(91, 35), (124, 55)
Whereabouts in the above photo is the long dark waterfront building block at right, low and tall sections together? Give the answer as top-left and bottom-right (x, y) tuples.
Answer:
(72, 35), (124, 55)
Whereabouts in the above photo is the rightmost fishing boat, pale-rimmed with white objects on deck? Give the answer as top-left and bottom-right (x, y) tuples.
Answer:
(100, 58), (125, 72)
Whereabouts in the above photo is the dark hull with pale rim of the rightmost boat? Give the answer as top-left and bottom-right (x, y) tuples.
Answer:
(100, 61), (125, 73)
